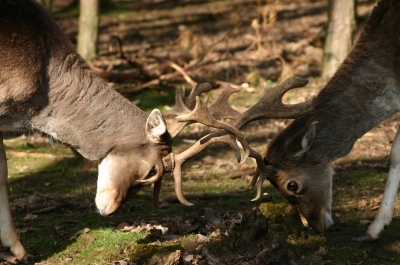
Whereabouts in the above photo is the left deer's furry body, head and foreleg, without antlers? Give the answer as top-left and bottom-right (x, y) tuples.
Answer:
(0, 0), (172, 259)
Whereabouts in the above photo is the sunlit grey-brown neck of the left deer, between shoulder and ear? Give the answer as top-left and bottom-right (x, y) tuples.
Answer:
(30, 54), (148, 160)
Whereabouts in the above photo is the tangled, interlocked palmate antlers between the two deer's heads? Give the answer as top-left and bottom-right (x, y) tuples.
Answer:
(153, 77), (315, 208)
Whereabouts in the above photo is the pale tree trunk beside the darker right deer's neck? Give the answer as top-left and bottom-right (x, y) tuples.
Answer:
(321, 0), (356, 78)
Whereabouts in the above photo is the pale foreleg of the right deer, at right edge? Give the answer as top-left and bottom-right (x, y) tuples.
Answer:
(357, 128), (400, 241)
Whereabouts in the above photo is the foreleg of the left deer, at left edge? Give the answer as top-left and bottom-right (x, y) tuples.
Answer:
(0, 132), (26, 260)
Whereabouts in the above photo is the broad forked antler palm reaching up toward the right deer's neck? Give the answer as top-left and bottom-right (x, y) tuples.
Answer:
(235, 76), (315, 129)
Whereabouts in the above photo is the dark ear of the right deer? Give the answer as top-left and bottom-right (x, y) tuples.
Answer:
(287, 121), (318, 159)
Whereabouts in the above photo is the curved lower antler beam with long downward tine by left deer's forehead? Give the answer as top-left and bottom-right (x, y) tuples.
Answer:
(171, 134), (244, 206)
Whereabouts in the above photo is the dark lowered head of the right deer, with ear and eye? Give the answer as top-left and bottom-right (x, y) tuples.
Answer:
(264, 118), (333, 232)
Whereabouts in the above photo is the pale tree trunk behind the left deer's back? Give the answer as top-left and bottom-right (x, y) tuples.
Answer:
(77, 0), (99, 61)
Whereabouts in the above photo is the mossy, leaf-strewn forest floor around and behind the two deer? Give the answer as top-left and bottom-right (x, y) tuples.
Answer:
(0, 0), (400, 265)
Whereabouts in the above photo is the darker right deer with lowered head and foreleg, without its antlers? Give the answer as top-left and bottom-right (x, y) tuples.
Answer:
(264, 0), (400, 241)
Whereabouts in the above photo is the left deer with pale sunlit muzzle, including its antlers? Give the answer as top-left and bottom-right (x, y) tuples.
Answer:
(0, 0), (312, 259)
